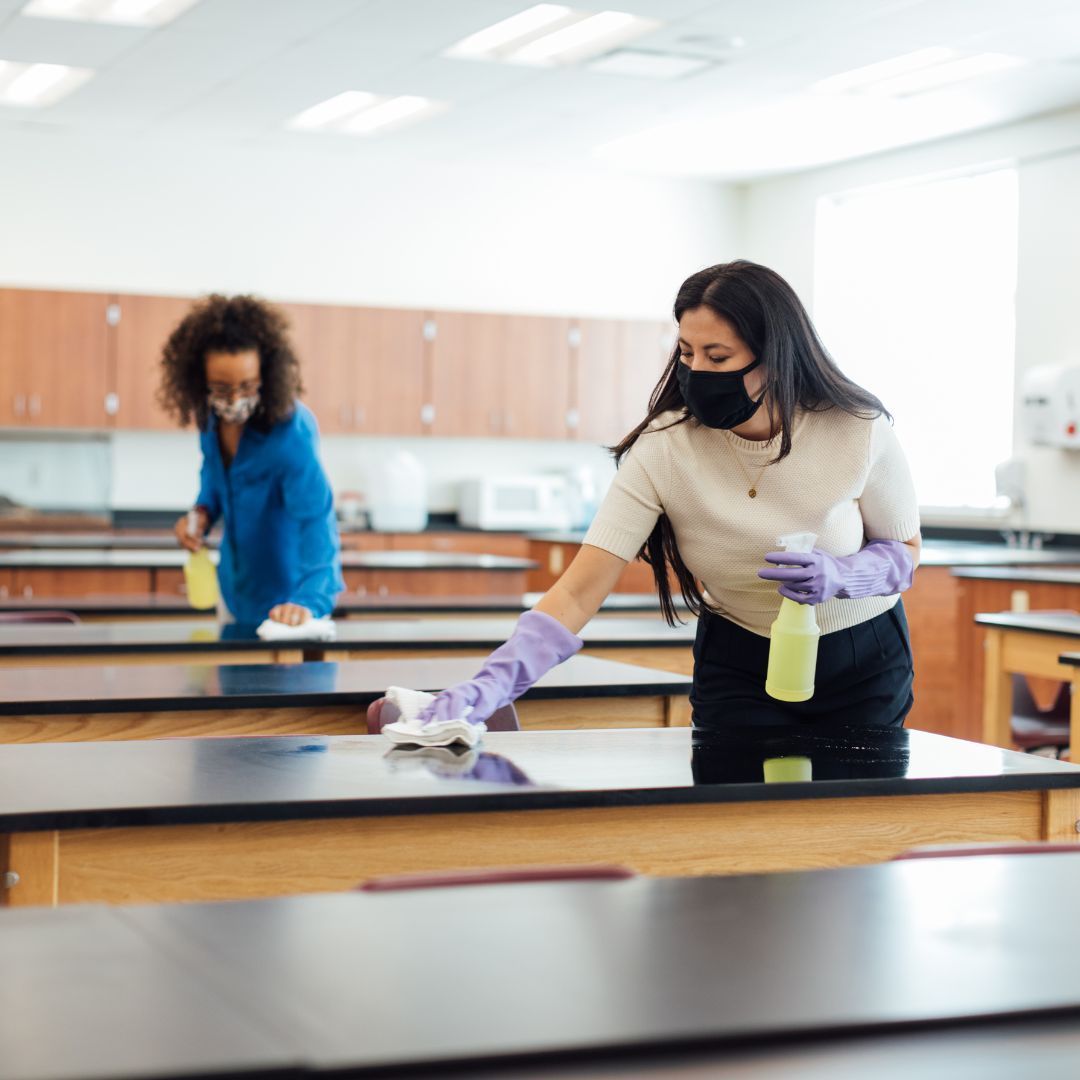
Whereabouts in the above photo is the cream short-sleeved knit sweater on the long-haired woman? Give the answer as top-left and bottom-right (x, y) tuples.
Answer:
(584, 408), (919, 637)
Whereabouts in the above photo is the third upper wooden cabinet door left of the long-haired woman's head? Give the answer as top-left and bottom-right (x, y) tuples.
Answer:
(502, 315), (570, 438)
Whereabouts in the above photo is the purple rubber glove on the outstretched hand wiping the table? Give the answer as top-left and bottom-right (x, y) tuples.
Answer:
(417, 611), (583, 724)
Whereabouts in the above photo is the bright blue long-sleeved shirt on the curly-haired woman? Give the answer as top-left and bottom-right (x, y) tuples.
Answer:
(197, 402), (345, 623)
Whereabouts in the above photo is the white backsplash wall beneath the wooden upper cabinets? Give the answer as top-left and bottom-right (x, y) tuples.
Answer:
(109, 432), (615, 513)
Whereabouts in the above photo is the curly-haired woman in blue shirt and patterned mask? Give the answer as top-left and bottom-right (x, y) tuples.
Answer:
(160, 296), (345, 625)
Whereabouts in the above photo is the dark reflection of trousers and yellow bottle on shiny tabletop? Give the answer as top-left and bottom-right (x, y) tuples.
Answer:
(691, 726), (910, 784)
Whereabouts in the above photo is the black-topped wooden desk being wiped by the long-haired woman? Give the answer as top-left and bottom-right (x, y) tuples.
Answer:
(0, 725), (1080, 922)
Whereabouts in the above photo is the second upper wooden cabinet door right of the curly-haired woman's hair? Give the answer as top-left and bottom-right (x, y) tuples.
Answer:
(350, 308), (431, 435)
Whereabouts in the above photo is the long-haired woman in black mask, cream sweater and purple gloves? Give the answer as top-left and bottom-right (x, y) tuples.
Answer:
(406, 260), (920, 727)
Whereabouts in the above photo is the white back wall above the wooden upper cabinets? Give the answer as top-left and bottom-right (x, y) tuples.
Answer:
(0, 132), (737, 319)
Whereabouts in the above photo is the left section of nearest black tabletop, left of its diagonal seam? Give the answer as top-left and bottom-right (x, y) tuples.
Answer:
(0, 906), (301, 1080)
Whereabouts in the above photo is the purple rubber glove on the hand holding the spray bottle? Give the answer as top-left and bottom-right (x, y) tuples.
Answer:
(757, 540), (915, 604)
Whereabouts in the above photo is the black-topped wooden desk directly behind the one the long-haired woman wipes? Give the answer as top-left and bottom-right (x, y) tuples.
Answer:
(0, 654), (690, 742)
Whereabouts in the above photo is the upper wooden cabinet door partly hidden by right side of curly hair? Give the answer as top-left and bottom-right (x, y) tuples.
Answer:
(279, 303), (356, 434)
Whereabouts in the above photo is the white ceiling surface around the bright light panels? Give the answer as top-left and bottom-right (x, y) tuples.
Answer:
(0, 0), (1080, 179)
